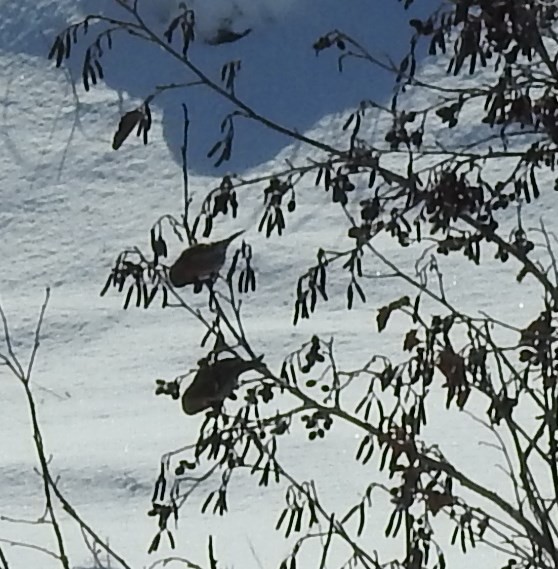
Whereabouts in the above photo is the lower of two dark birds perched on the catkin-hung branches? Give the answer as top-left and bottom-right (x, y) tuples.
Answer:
(182, 356), (263, 415)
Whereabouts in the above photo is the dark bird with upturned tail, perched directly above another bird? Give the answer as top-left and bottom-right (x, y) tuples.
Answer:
(169, 230), (244, 288)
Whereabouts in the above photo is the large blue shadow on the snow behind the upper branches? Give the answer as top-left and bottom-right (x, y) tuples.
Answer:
(0, 0), (439, 175)
